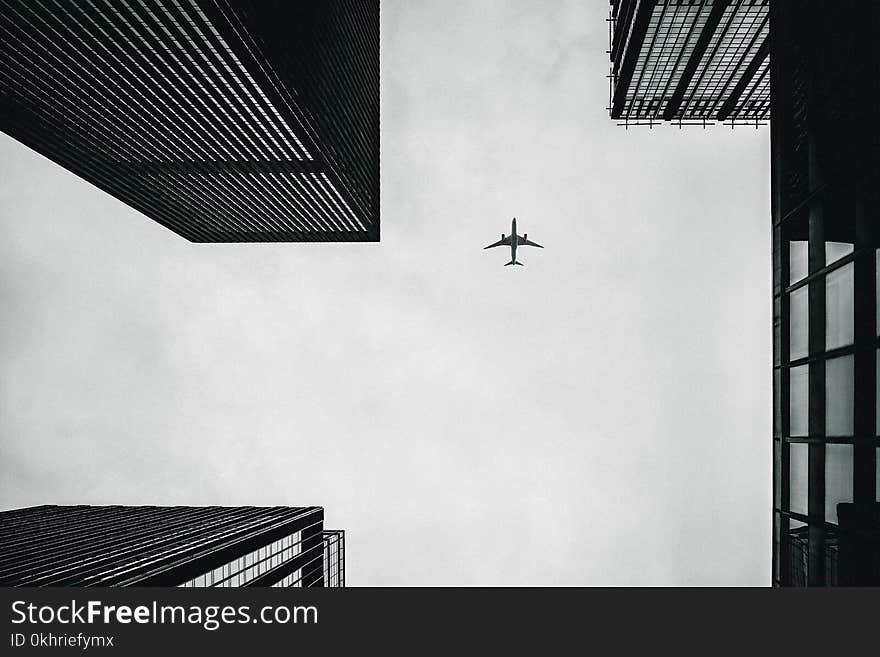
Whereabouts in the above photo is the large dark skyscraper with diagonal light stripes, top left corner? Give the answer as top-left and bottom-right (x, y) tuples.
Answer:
(0, 0), (379, 242)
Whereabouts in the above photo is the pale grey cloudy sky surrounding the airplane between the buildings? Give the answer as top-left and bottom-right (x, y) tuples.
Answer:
(0, 0), (771, 585)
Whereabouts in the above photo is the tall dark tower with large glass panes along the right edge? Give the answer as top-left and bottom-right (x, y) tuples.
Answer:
(771, 0), (880, 586)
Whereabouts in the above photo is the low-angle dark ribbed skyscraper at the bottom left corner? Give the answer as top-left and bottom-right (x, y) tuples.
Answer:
(0, 506), (345, 587)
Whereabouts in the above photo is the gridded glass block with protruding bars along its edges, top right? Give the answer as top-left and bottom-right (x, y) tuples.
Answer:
(609, 0), (770, 125)
